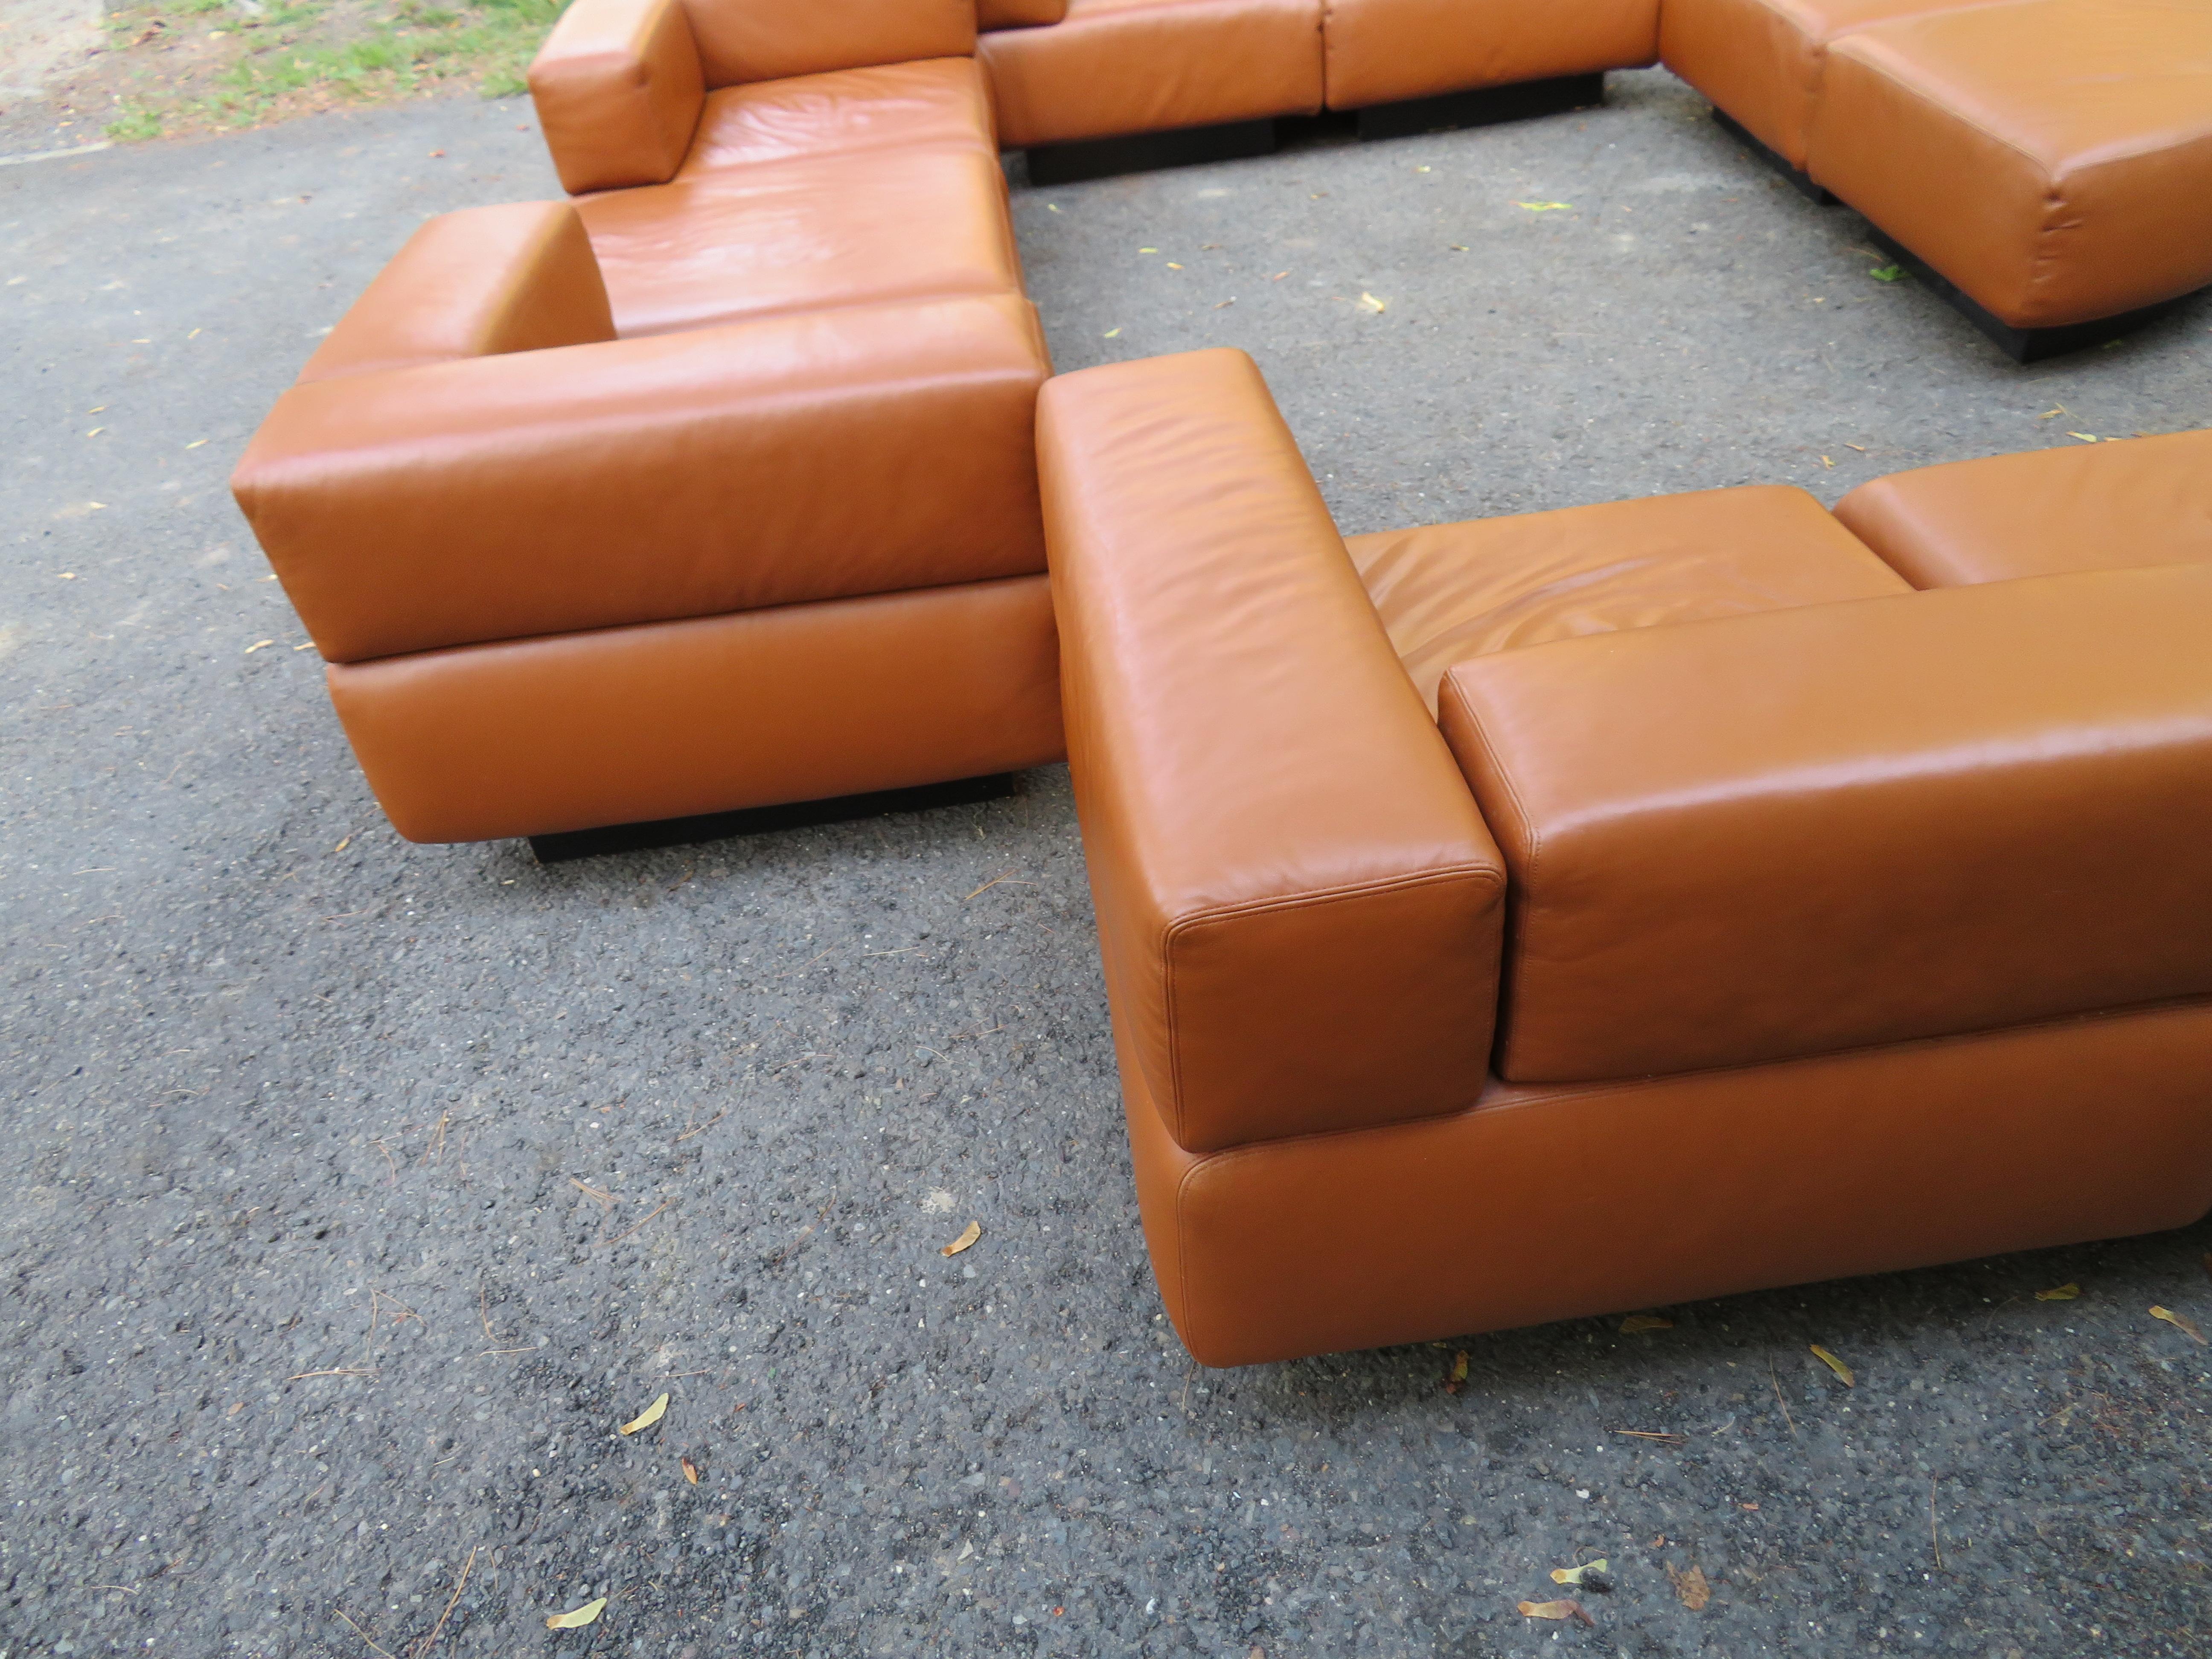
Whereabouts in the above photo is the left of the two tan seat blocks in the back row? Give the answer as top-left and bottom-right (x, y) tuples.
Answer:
(980, 0), (1323, 148)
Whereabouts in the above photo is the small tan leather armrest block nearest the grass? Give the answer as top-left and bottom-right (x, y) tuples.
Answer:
(531, 0), (706, 195)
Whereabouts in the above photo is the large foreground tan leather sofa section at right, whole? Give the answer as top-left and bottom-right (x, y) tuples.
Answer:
(1039, 352), (2212, 1365)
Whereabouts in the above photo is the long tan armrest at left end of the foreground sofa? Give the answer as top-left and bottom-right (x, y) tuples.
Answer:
(1037, 352), (1504, 1153)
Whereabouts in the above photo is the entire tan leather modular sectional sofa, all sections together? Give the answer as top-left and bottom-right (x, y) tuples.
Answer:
(235, 0), (2212, 1365)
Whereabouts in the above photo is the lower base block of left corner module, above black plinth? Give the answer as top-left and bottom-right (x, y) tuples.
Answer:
(329, 575), (1062, 841)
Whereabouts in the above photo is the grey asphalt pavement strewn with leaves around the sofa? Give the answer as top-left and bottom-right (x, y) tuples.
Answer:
(0, 73), (2212, 1659)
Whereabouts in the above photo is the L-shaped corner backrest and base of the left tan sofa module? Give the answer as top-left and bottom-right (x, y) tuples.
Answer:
(232, 204), (1062, 841)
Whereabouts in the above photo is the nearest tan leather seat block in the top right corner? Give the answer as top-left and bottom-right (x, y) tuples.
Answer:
(1807, 0), (2212, 327)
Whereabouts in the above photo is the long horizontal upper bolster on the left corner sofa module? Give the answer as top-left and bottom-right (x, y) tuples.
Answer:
(232, 299), (1051, 661)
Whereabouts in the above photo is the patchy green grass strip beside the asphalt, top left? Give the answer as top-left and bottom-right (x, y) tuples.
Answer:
(106, 0), (566, 140)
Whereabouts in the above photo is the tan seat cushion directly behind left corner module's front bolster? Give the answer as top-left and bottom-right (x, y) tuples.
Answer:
(577, 148), (1022, 338)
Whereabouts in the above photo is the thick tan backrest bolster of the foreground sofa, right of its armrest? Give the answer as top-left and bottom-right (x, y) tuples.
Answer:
(1442, 564), (2212, 1084)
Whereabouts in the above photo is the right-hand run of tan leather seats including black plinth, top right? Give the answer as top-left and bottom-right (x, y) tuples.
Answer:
(1659, 0), (2212, 361)
